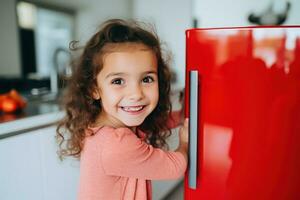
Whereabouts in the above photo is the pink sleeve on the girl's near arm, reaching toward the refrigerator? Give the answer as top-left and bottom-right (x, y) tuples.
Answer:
(101, 128), (187, 180)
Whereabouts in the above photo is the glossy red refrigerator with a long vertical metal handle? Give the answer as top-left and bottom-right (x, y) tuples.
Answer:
(184, 26), (300, 200)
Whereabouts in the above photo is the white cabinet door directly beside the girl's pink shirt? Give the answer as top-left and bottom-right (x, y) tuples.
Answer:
(39, 126), (79, 200)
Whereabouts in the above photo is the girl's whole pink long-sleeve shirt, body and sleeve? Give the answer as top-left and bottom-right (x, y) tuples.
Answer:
(78, 126), (187, 200)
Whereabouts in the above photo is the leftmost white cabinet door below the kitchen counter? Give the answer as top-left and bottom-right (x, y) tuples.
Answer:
(0, 131), (43, 200)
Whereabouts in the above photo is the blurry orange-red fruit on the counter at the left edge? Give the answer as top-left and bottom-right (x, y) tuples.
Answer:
(0, 89), (27, 113)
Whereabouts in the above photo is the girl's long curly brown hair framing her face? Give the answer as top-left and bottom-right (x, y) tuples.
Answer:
(56, 19), (172, 158)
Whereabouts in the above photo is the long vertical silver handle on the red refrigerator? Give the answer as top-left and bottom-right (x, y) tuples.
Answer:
(188, 71), (198, 189)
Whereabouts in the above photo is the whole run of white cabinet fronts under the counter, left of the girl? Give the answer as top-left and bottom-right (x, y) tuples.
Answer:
(0, 126), (79, 200)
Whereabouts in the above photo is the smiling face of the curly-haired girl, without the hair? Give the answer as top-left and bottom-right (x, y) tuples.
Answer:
(94, 44), (159, 127)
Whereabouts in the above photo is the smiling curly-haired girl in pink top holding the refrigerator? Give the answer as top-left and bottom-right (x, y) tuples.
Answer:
(57, 20), (188, 200)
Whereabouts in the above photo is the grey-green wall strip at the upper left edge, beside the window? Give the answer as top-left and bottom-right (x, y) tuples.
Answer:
(0, 0), (21, 76)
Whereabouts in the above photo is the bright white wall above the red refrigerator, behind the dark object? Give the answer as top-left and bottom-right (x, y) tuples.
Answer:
(193, 0), (300, 27)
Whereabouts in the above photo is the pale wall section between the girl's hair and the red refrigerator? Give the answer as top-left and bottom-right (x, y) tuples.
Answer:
(132, 0), (192, 89)
